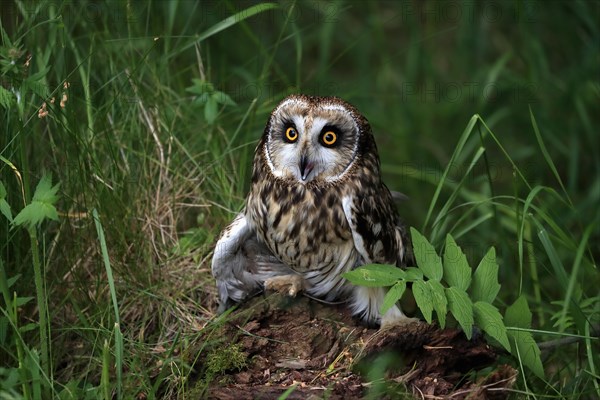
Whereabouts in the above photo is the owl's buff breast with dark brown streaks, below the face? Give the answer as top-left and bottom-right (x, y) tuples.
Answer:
(246, 180), (355, 272)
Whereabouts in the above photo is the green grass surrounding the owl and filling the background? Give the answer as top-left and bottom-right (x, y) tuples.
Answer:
(0, 0), (600, 399)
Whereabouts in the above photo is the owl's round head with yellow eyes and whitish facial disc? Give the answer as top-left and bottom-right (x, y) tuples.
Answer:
(257, 95), (378, 183)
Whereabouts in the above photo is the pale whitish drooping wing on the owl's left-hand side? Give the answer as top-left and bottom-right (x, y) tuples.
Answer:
(211, 212), (290, 313)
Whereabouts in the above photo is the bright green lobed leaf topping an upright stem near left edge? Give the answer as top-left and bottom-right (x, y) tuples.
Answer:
(12, 174), (60, 229)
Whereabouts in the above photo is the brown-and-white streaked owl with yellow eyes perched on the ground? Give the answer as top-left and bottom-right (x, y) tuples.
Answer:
(212, 95), (410, 325)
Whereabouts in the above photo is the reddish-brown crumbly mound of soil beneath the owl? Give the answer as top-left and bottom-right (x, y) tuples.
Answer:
(207, 294), (516, 400)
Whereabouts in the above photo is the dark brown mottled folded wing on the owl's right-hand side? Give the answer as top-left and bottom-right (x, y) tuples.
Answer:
(342, 184), (410, 266)
